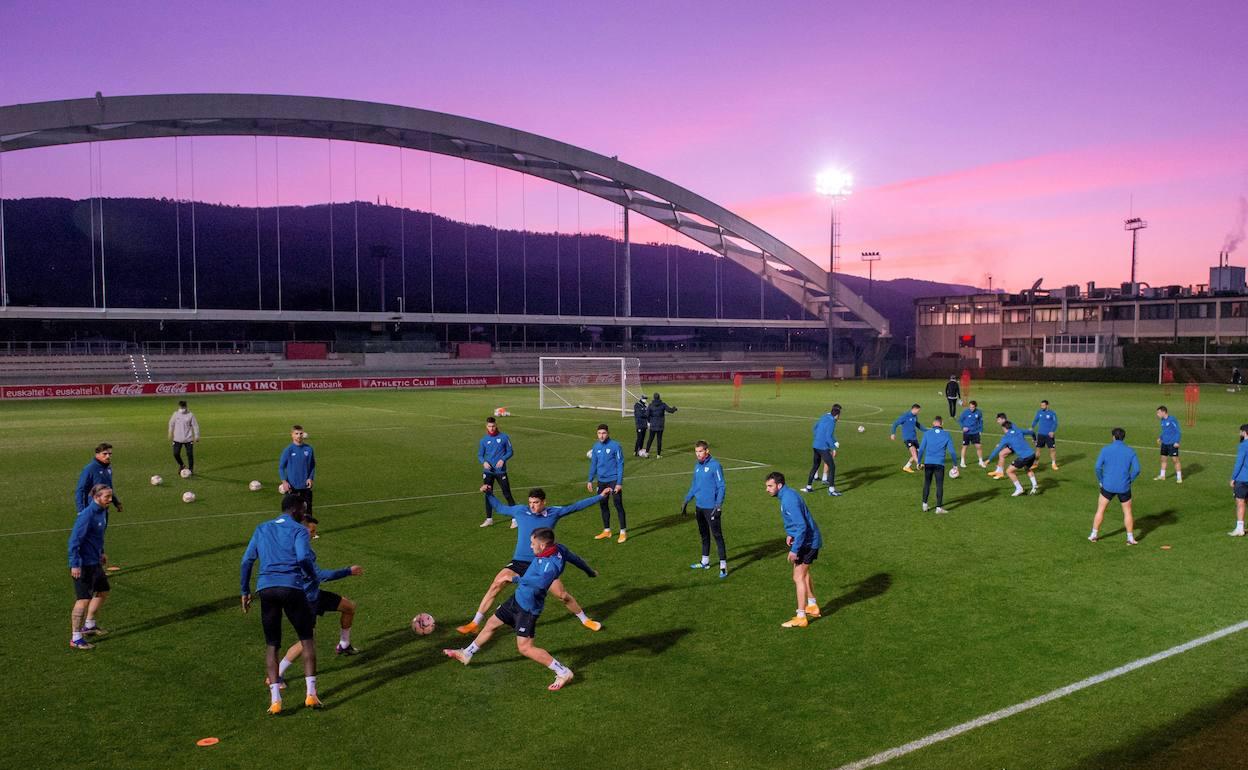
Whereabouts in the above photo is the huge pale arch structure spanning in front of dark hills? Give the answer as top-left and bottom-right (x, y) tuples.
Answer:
(0, 94), (889, 359)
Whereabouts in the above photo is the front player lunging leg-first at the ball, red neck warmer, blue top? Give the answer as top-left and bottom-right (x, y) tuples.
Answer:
(442, 528), (586, 691)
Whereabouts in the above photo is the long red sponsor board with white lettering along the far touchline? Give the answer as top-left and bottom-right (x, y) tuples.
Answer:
(0, 369), (811, 401)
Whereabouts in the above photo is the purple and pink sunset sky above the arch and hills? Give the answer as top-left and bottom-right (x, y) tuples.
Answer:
(0, 0), (1248, 288)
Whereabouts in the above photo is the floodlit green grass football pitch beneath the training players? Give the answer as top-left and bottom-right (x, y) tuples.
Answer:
(0, 381), (1248, 770)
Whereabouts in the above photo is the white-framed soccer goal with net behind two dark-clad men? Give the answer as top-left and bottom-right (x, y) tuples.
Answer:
(538, 356), (641, 417)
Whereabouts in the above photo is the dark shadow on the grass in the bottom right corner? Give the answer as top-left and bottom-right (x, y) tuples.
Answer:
(1071, 688), (1248, 770)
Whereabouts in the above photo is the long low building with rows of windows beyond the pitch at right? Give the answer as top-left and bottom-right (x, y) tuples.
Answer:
(915, 267), (1248, 368)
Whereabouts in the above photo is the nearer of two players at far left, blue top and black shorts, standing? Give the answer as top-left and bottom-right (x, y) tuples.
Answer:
(69, 484), (112, 650)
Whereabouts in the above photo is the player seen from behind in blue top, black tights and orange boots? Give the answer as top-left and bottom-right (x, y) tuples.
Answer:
(238, 493), (321, 714)
